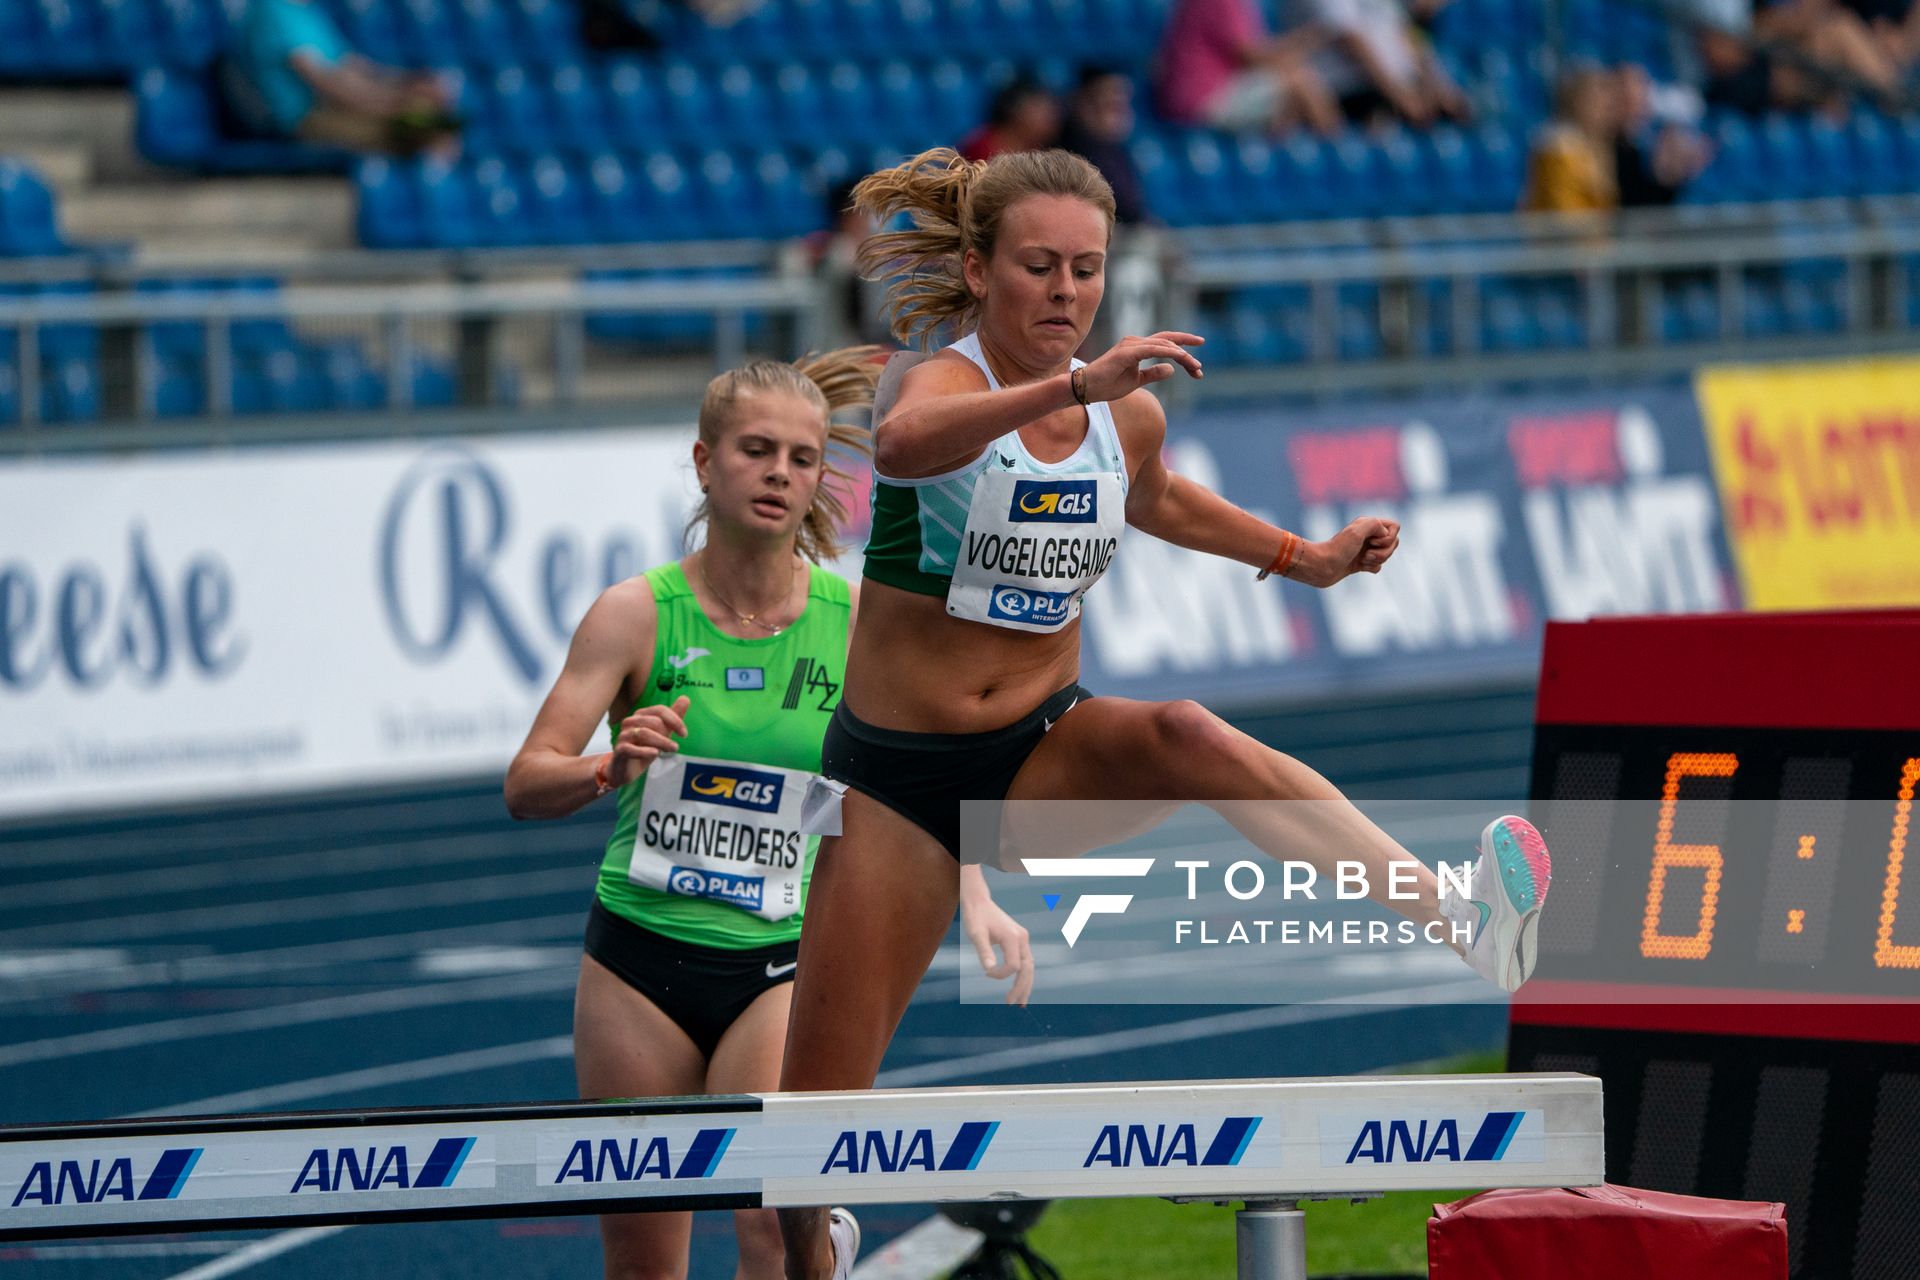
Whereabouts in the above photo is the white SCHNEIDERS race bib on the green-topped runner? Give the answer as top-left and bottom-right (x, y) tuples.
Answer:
(626, 756), (839, 919)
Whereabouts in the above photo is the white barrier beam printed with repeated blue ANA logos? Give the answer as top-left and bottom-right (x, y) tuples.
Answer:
(0, 1073), (1605, 1240)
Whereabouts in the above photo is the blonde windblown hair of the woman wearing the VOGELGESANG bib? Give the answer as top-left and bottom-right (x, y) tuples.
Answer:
(852, 146), (1114, 347)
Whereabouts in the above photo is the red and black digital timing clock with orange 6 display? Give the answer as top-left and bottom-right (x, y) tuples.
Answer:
(1509, 610), (1920, 1280)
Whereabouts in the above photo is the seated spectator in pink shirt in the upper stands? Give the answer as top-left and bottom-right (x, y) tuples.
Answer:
(1156, 0), (1340, 134)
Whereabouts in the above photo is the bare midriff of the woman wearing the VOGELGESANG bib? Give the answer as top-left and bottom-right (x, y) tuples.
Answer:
(841, 578), (1079, 733)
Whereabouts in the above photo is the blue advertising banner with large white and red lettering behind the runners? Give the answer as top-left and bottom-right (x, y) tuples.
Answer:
(1085, 388), (1738, 702)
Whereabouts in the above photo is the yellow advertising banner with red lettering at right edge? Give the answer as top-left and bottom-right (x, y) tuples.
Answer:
(1695, 359), (1920, 608)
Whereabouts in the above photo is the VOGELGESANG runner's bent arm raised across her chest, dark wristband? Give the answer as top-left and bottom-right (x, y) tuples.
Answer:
(874, 332), (1204, 480)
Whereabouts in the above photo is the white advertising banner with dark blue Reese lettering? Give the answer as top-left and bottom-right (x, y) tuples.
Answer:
(0, 432), (697, 816)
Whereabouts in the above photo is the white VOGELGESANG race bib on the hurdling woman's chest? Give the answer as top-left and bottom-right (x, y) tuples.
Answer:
(947, 470), (1127, 631)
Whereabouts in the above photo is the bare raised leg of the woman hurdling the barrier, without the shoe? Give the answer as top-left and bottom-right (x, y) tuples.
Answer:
(1008, 699), (1440, 923)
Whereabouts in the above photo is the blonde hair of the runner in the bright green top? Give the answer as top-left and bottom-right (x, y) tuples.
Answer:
(685, 347), (881, 564)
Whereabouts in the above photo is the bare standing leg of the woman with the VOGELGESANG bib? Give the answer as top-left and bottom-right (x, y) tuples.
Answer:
(780, 791), (960, 1280)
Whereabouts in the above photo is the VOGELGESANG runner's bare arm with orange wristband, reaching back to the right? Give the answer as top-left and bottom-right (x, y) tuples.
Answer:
(1114, 395), (1400, 587)
